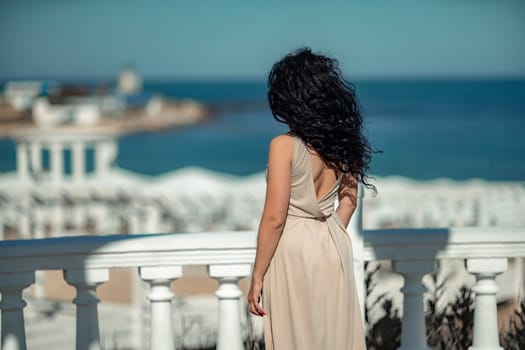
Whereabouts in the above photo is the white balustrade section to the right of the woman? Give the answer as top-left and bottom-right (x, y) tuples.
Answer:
(363, 227), (525, 350)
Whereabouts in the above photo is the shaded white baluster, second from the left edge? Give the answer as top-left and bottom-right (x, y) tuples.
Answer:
(64, 269), (109, 350)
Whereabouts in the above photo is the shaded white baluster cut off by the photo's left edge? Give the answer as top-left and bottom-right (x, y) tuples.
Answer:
(0, 272), (35, 350)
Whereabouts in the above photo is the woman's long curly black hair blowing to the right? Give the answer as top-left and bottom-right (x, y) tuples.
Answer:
(268, 48), (377, 192)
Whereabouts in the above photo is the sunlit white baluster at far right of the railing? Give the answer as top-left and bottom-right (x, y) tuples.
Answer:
(466, 258), (507, 350)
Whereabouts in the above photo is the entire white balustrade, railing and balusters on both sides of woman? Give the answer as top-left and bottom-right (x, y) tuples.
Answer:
(0, 227), (525, 350)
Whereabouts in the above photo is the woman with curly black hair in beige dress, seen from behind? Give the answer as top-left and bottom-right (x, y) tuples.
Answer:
(248, 49), (375, 350)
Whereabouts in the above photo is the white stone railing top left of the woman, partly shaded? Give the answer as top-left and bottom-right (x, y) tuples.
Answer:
(0, 231), (256, 273)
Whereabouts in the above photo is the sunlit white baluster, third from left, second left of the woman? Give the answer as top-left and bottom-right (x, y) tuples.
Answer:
(139, 266), (182, 350)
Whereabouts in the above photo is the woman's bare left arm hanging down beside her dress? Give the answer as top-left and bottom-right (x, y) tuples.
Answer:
(248, 135), (293, 316)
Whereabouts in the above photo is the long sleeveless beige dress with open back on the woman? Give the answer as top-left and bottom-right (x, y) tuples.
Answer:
(262, 137), (366, 350)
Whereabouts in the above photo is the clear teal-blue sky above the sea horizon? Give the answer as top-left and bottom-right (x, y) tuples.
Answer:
(0, 0), (525, 80)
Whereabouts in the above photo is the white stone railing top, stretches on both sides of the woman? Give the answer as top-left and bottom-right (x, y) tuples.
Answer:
(0, 227), (525, 273)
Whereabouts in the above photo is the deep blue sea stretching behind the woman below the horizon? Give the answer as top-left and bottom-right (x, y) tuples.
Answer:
(0, 80), (525, 181)
